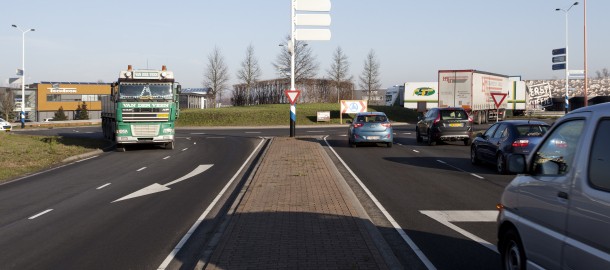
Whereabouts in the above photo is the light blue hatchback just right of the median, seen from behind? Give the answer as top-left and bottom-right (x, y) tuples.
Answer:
(347, 112), (394, 147)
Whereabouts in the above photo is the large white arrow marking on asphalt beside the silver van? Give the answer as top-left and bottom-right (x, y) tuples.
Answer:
(419, 210), (498, 253)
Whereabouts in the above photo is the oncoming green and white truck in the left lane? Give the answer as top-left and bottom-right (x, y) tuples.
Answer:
(102, 65), (180, 152)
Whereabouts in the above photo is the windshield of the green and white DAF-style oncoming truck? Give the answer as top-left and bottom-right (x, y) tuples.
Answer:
(119, 83), (172, 100)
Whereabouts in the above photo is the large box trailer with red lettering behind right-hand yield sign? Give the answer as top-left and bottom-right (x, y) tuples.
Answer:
(438, 69), (525, 124)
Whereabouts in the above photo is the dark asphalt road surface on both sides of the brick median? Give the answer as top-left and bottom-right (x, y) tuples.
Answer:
(0, 125), (513, 269)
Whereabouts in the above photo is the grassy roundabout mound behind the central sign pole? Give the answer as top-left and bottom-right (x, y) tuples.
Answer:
(176, 103), (417, 127)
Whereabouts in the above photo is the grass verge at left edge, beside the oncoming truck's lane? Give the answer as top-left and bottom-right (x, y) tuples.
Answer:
(0, 132), (108, 183)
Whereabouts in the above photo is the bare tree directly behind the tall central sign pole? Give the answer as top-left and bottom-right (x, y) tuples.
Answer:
(273, 36), (318, 82)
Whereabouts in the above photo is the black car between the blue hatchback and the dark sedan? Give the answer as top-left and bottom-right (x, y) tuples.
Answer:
(415, 107), (473, 145)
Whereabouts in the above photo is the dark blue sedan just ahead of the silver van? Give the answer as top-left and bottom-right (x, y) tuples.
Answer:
(470, 120), (550, 174)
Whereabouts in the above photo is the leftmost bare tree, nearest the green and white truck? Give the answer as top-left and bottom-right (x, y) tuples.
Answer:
(203, 47), (229, 108)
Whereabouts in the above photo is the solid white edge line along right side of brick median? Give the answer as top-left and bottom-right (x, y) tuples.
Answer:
(324, 136), (436, 270)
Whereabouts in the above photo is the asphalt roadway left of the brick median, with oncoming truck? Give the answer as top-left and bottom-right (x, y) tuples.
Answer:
(0, 128), (262, 269)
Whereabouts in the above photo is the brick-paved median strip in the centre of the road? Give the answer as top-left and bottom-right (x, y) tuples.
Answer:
(205, 137), (400, 269)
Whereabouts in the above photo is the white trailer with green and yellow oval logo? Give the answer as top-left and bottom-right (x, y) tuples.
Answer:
(404, 82), (438, 113)
